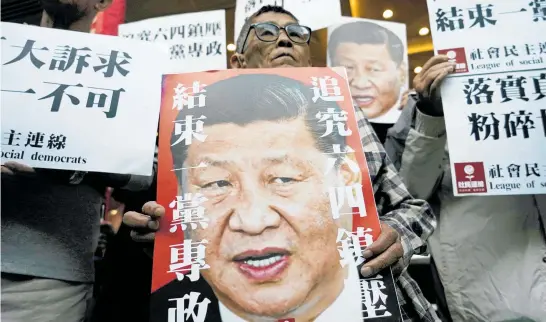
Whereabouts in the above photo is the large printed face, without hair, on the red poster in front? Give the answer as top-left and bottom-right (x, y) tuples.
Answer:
(181, 118), (352, 317)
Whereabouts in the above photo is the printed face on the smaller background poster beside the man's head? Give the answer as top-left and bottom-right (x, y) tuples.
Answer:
(333, 42), (407, 119)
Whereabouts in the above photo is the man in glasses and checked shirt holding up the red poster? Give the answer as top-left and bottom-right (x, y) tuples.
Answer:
(124, 6), (439, 322)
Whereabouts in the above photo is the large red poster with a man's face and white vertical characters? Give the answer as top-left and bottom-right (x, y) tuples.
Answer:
(150, 68), (401, 322)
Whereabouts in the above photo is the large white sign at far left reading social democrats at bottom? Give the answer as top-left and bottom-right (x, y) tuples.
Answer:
(1, 22), (166, 175)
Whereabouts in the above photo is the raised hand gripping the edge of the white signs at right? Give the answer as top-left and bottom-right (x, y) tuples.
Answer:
(413, 55), (455, 99)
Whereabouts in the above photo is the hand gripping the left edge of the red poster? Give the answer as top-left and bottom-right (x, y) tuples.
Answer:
(123, 201), (165, 247)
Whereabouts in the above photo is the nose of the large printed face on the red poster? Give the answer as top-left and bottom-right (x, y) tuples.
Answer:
(228, 191), (281, 235)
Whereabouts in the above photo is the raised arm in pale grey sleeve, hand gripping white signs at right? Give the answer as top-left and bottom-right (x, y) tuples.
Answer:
(385, 55), (454, 199)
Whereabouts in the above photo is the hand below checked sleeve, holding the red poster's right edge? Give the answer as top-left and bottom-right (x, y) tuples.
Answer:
(360, 223), (404, 277)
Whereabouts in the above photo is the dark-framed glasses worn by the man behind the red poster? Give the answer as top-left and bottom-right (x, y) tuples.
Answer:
(241, 22), (311, 53)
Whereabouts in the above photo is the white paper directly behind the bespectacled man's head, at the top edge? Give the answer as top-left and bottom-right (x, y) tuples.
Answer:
(233, 0), (341, 39)
